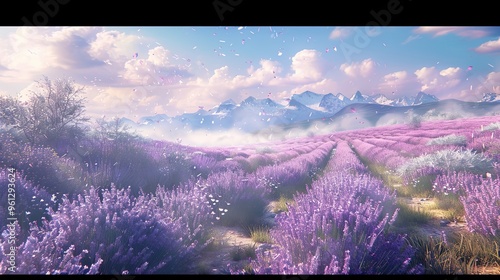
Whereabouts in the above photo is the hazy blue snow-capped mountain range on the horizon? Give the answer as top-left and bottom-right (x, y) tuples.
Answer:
(122, 91), (500, 133)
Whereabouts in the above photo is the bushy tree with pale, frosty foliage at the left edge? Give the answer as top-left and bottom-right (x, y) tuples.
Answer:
(0, 76), (89, 146)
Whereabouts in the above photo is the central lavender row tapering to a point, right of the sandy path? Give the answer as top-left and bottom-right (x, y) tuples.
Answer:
(240, 141), (423, 274)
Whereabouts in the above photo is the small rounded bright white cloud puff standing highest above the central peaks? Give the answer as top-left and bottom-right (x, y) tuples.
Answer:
(290, 49), (328, 83)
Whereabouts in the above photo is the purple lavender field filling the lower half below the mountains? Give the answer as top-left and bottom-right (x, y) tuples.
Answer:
(0, 112), (500, 274)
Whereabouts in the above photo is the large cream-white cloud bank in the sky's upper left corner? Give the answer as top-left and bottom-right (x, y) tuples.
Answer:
(0, 27), (143, 84)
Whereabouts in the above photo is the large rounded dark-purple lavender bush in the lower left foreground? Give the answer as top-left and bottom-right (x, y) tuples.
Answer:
(0, 186), (211, 274)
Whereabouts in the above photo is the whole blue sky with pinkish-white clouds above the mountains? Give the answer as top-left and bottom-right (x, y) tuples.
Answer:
(0, 26), (500, 120)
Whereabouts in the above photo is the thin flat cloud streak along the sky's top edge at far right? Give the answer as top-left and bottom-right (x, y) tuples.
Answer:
(414, 26), (498, 38)
